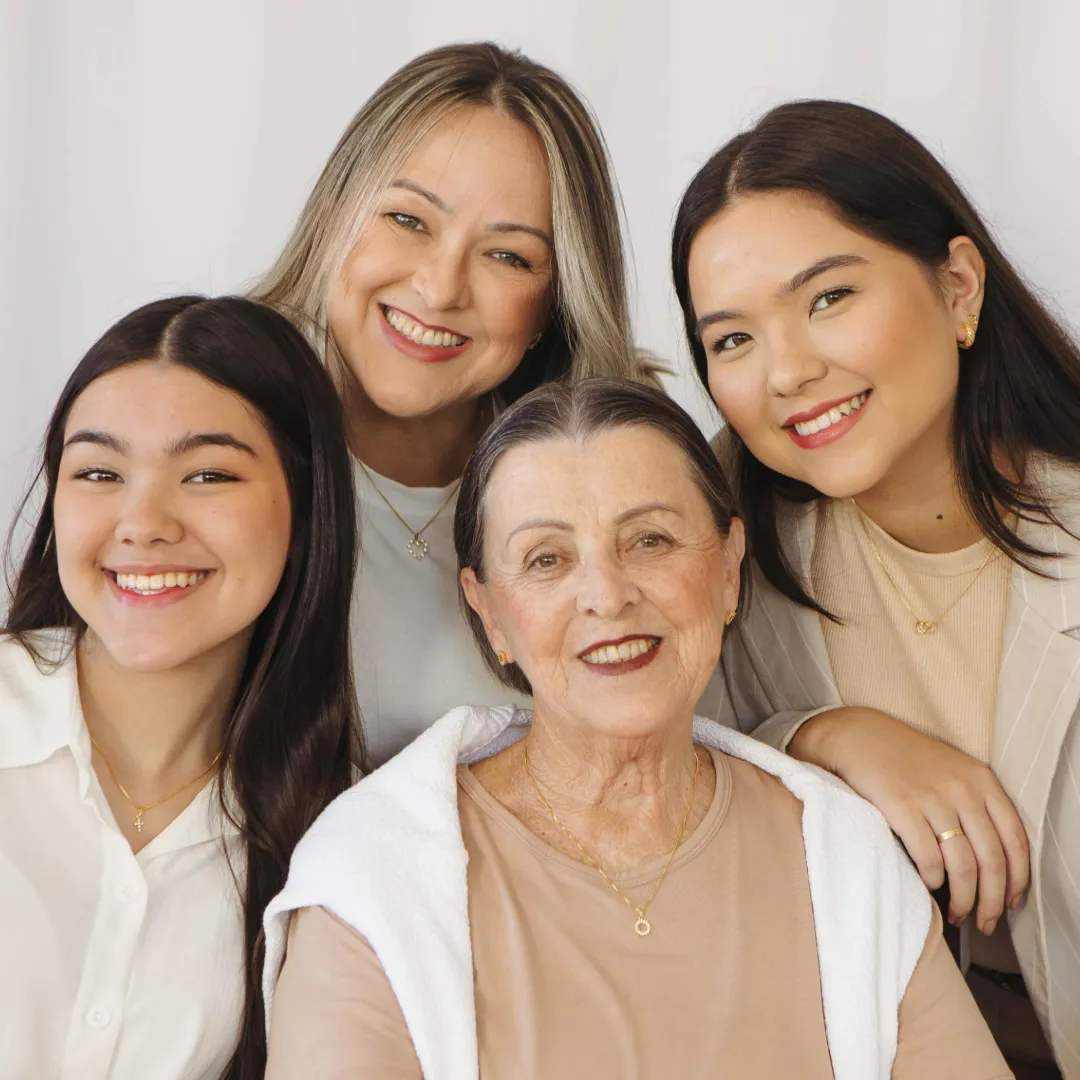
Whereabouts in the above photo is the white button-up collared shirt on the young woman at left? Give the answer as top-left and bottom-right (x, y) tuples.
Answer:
(0, 635), (244, 1080)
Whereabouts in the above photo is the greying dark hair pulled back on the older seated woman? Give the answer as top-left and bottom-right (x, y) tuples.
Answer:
(454, 378), (748, 693)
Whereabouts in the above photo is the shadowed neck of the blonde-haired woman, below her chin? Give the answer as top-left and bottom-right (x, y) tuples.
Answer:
(345, 380), (494, 487)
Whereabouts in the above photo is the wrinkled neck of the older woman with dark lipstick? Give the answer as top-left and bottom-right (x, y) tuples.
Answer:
(486, 712), (715, 874)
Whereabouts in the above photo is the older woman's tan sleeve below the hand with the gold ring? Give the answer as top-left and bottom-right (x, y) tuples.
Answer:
(892, 904), (1012, 1080)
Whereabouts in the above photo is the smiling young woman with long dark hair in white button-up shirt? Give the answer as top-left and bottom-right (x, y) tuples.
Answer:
(0, 296), (361, 1080)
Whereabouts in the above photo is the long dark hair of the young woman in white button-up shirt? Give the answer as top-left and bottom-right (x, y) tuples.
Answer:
(4, 296), (362, 1080)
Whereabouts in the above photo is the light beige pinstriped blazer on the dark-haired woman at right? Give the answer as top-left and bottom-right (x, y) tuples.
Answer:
(698, 462), (1080, 1080)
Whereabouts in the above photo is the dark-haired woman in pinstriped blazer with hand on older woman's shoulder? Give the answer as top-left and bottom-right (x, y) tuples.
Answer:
(672, 102), (1080, 1077)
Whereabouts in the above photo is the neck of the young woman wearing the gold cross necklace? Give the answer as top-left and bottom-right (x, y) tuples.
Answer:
(78, 633), (246, 805)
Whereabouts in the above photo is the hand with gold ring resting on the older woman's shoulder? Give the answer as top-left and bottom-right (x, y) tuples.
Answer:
(787, 706), (1030, 934)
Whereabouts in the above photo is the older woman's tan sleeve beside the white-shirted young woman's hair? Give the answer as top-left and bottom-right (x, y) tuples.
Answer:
(266, 907), (423, 1080)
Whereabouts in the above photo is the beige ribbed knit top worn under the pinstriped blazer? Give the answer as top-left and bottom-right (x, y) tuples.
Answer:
(810, 499), (1012, 762)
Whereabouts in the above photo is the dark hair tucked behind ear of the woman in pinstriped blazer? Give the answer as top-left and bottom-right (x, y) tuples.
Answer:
(672, 102), (1080, 611)
